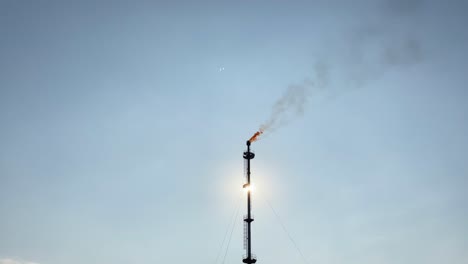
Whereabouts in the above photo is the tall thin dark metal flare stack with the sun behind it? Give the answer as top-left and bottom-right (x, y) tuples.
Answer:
(242, 140), (257, 263)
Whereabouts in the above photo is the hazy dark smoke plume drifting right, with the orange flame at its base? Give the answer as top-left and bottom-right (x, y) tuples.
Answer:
(252, 7), (424, 141)
